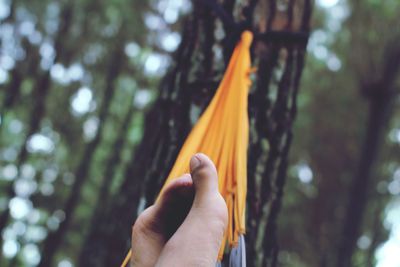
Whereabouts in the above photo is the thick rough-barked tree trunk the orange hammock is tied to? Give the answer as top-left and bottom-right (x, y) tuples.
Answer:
(80, 0), (311, 266)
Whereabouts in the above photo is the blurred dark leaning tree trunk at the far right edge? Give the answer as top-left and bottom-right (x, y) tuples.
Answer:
(336, 37), (400, 267)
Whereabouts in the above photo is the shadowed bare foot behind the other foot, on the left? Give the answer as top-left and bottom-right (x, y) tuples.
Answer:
(131, 174), (194, 266)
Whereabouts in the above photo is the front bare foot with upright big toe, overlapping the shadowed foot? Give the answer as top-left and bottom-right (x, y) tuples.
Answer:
(157, 154), (228, 266)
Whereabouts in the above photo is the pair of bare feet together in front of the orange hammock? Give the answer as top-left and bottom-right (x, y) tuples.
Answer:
(131, 154), (228, 267)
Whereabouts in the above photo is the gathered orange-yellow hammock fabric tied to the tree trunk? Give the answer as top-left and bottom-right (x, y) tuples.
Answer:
(122, 31), (253, 266)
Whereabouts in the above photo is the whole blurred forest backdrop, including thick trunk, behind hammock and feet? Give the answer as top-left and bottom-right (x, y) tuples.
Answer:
(0, 0), (400, 267)
